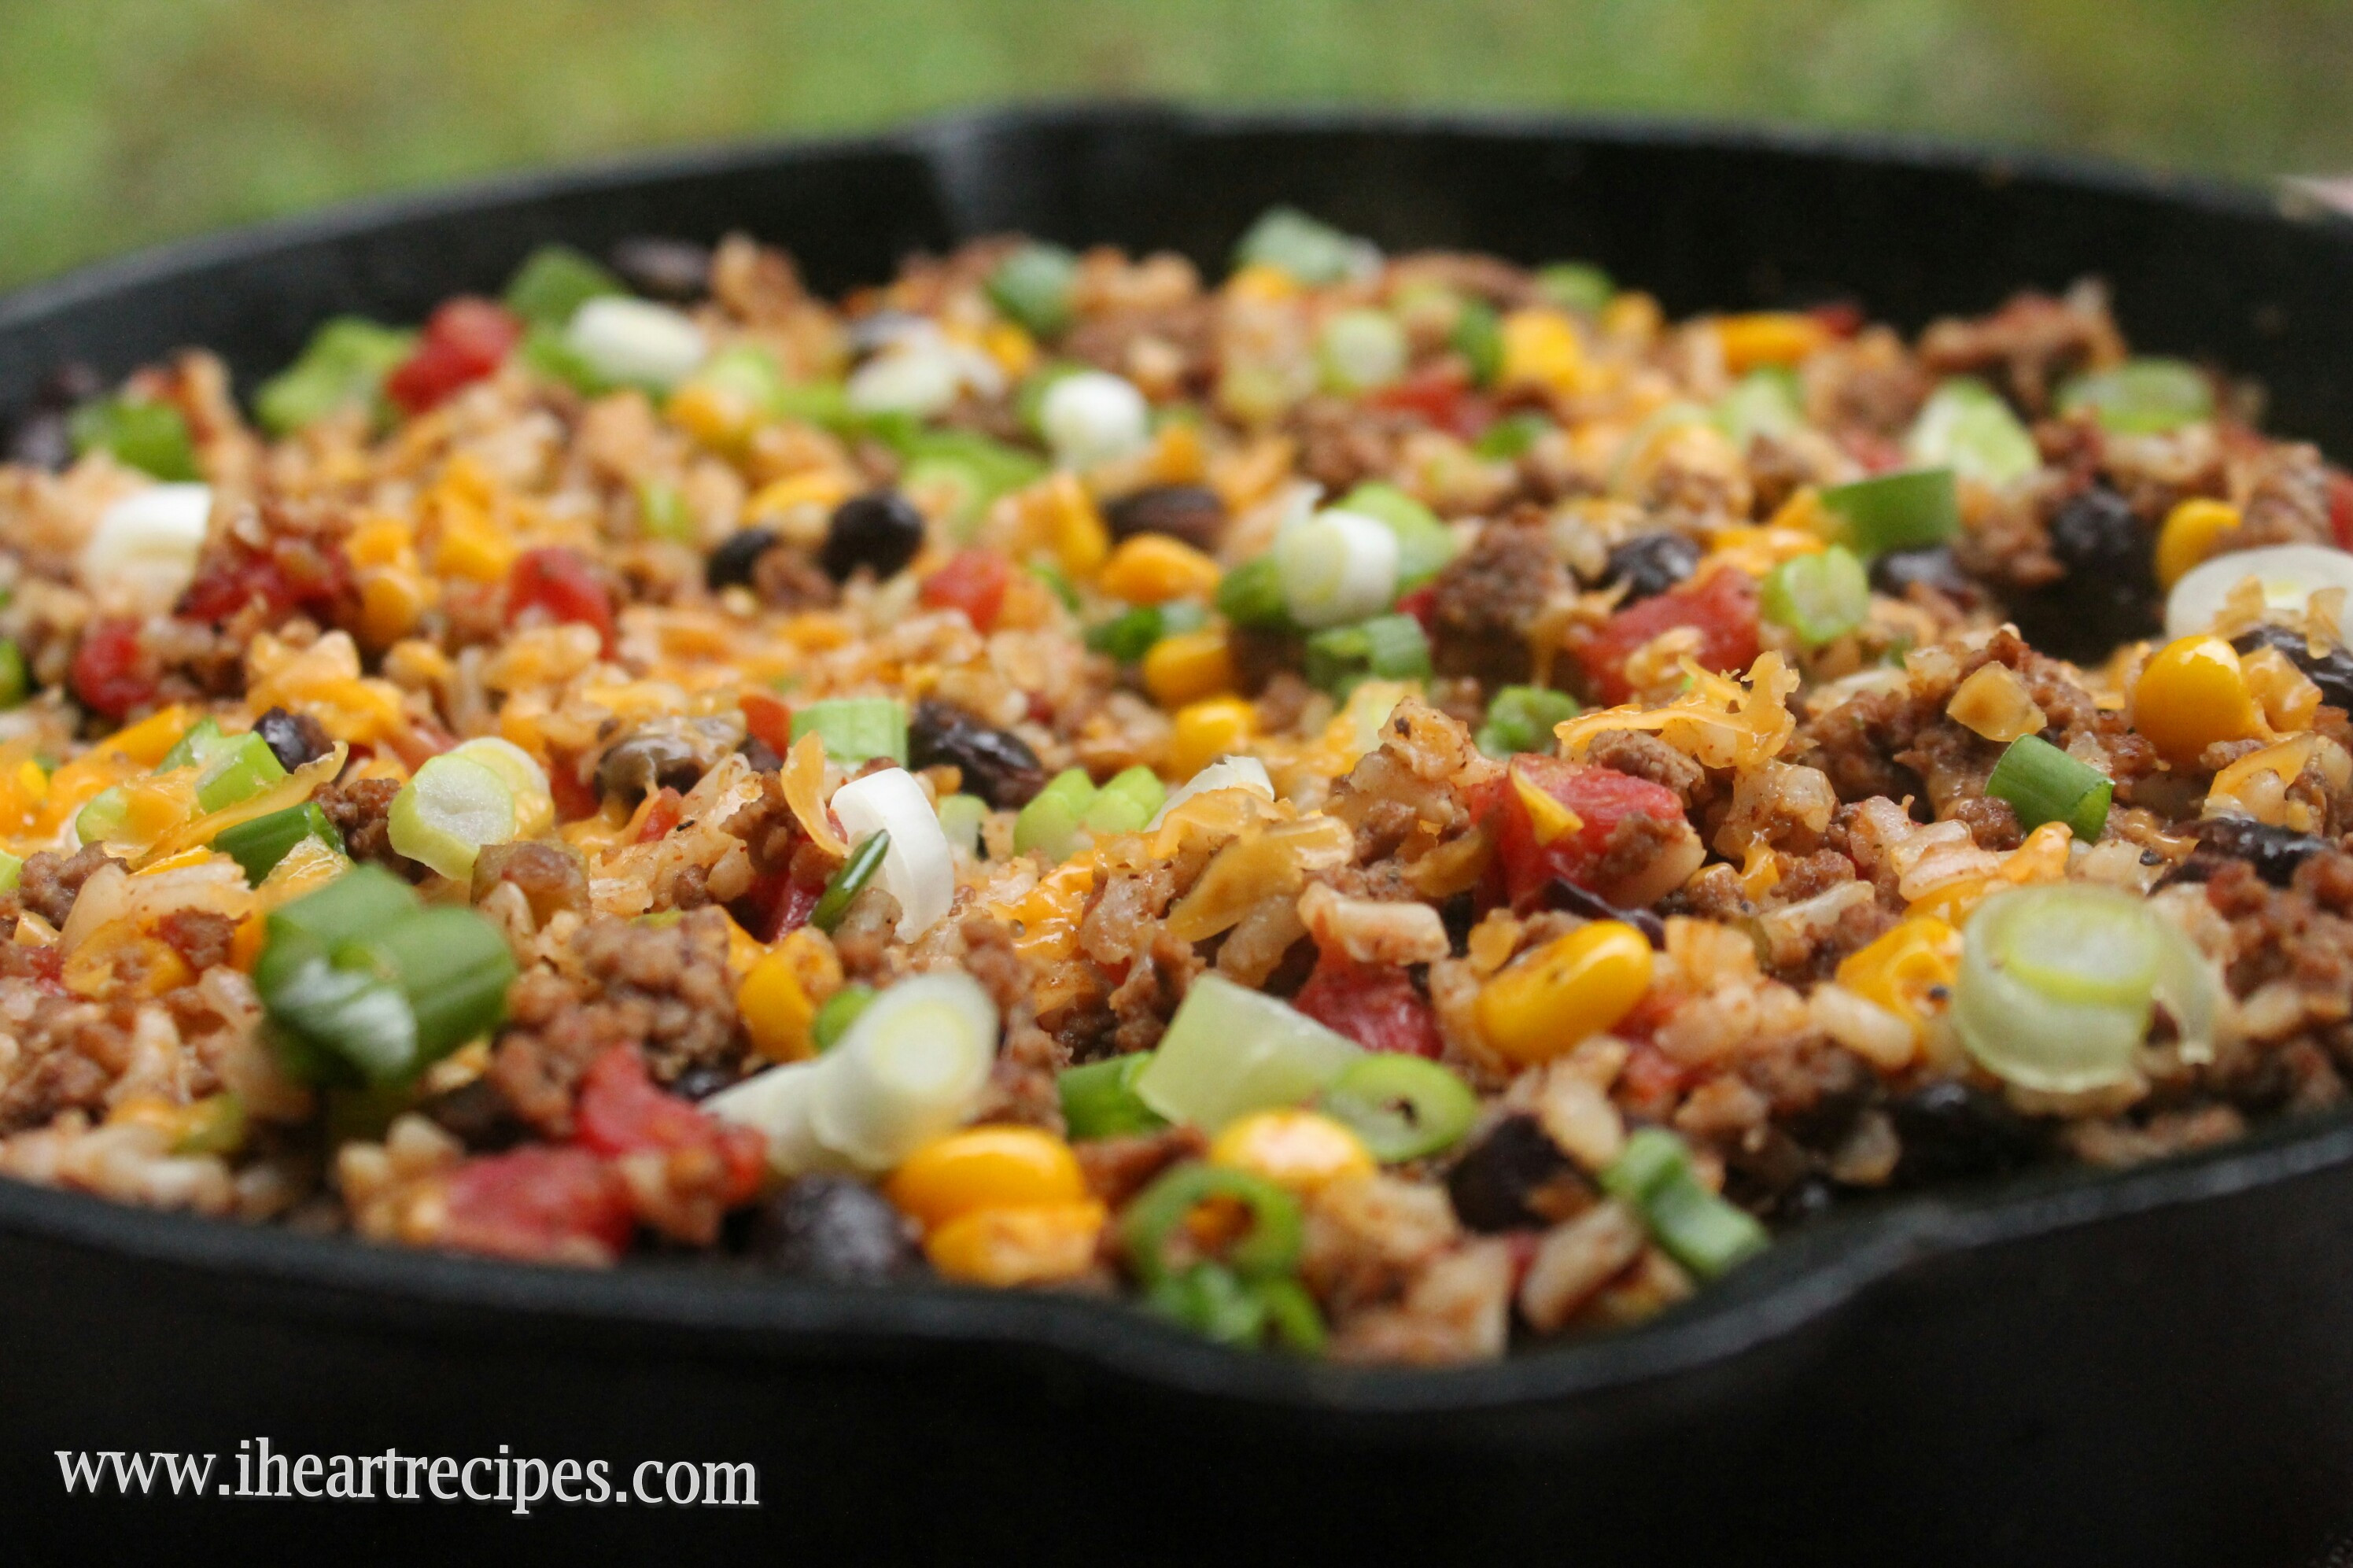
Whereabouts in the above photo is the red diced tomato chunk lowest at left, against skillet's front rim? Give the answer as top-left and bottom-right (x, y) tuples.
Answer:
(440, 1144), (636, 1262)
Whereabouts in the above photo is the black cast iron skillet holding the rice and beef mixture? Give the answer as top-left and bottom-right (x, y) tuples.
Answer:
(0, 109), (2353, 1563)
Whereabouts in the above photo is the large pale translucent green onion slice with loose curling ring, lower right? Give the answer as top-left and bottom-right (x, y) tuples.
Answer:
(1953, 883), (2217, 1095)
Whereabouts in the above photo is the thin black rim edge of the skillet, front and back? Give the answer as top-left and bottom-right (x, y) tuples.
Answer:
(0, 104), (2353, 1417)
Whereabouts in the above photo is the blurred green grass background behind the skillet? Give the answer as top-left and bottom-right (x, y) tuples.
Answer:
(0, 0), (2353, 287)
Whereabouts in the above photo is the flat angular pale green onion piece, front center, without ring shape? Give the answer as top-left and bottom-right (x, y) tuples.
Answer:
(1137, 975), (1365, 1132)
